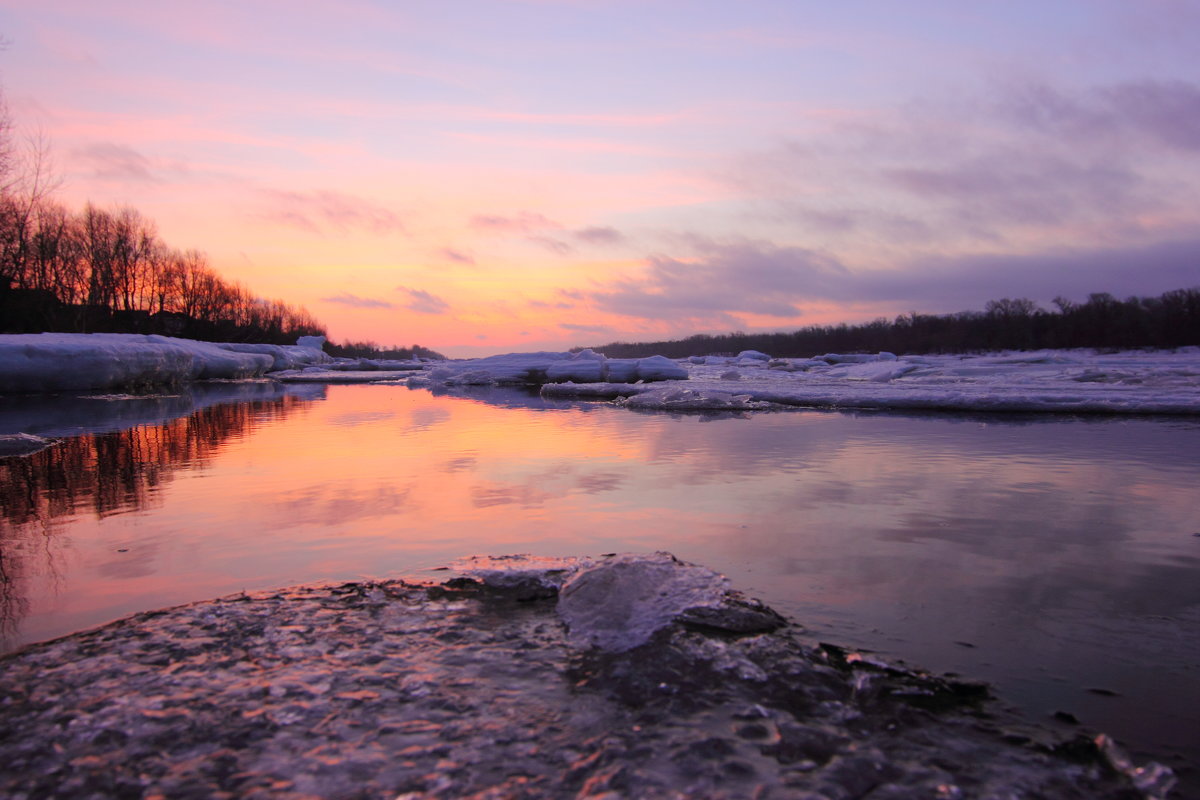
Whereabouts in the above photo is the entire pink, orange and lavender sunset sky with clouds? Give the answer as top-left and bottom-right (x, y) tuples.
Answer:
(0, 0), (1200, 356)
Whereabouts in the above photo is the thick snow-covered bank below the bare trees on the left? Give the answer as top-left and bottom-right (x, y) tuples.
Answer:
(0, 333), (330, 393)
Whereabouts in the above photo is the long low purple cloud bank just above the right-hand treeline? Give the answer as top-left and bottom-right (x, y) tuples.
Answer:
(571, 234), (1200, 327)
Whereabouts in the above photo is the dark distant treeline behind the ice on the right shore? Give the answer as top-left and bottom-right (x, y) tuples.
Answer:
(593, 287), (1200, 359)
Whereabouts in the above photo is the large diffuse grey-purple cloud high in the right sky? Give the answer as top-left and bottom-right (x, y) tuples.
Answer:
(725, 80), (1200, 252)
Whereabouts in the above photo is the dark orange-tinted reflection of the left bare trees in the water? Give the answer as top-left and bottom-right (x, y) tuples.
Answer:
(0, 395), (313, 643)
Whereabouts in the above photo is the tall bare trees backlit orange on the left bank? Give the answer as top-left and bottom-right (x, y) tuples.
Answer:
(0, 199), (325, 344)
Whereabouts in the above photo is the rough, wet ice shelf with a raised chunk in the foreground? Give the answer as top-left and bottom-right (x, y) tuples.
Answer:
(0, 553), (1174, 800)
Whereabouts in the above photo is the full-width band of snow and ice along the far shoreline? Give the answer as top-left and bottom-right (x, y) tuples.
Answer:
(0, 333), (1200, 419)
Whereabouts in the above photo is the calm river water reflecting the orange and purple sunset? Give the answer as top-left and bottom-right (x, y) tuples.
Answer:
(0, 386), (1200, 782)
